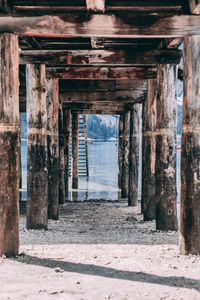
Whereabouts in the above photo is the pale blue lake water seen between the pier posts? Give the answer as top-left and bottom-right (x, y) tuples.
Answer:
(22, 140), (180, 201)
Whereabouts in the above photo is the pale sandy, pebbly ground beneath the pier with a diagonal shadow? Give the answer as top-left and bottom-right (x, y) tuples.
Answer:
(0, 203), (200, 300)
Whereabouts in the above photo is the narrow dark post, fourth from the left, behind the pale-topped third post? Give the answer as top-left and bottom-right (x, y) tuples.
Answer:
(59, 101), (65, 204)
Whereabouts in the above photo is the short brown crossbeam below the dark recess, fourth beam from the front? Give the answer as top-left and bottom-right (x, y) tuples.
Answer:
(60, 89), (146, 105)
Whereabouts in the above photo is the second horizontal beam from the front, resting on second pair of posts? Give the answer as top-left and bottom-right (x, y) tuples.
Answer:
(20, 49), (182, 66)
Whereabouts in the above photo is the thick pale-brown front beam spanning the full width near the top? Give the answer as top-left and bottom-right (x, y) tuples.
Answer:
(0, 14), (200, 38)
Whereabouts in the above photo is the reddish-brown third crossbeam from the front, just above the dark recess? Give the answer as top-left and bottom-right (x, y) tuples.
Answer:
(46, 67), (157, 80)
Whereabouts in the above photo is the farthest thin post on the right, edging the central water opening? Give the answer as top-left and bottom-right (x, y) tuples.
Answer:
(118, 114), (124, 189)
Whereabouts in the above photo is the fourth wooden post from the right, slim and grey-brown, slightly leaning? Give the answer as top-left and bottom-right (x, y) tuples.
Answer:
(128, 103), (141, 206)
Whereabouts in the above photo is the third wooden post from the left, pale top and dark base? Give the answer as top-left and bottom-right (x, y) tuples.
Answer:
(47, 79), (59, 220)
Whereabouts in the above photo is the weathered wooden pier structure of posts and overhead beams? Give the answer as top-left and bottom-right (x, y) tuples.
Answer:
(0, 0), (200, 256)
